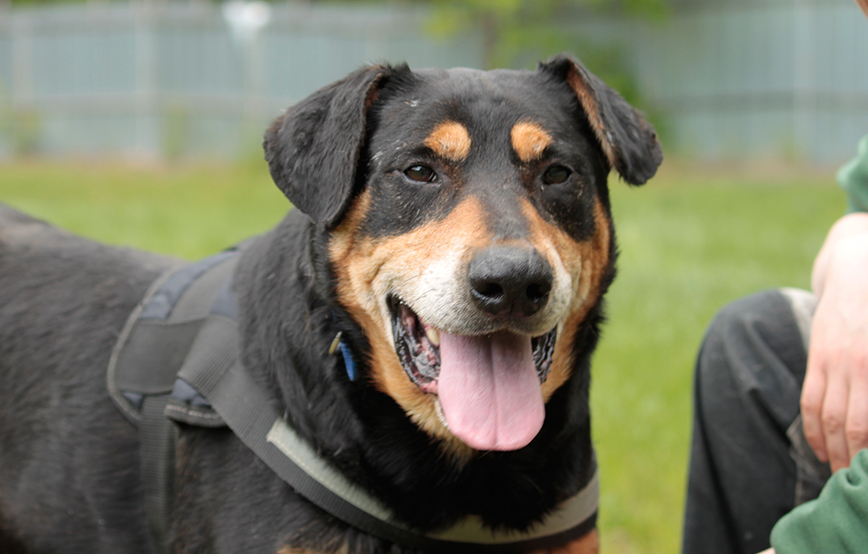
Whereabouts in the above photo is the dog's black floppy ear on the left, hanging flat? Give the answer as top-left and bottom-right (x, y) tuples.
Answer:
(263, 66), (392, 227)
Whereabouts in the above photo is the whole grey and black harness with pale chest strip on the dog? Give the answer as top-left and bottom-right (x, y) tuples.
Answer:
(107, 249), (599, 554)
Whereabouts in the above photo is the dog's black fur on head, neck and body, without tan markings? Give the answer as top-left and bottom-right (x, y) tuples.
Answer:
(0, 52), (659, 554)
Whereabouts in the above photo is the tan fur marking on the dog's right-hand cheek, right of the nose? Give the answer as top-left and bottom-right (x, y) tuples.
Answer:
(521, 195), (610, 396)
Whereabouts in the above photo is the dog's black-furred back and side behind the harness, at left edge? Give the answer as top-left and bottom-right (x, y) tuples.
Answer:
(0, 205), (171, 554)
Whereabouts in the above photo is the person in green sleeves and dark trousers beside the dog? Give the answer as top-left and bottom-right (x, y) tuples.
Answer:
(682, 0), (868, 554)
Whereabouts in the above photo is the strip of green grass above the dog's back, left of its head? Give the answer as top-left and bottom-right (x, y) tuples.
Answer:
(0, 157), (289, 260)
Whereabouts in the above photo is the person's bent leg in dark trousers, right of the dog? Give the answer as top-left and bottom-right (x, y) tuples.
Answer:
(682, 290), (818, 554)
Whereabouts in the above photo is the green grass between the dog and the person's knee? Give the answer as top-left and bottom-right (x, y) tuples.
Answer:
(592, 162), (844, 554)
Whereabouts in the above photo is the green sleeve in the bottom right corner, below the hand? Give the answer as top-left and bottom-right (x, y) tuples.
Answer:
(772, 449), (868, 554)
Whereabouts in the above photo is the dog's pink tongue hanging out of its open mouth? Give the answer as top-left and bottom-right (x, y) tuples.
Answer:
(437, 331), (545, 450)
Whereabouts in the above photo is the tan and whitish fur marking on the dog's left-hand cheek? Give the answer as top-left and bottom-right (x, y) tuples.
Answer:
(329, 193), (491, 459)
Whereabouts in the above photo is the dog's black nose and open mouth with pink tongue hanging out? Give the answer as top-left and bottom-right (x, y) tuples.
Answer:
(389, 246), (557, 450)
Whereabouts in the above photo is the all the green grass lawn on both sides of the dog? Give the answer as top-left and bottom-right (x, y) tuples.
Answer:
(0, 157), (843, 554)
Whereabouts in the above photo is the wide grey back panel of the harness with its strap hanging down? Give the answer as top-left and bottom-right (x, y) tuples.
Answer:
(107, 251), (238, 554)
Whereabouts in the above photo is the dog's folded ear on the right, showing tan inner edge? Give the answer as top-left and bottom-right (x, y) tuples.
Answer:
(537, 54), (663, 185)
